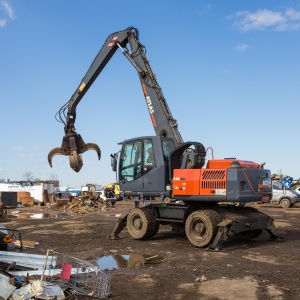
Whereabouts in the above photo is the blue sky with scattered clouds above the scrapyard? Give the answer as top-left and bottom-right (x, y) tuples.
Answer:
(0, 0), (300, 187)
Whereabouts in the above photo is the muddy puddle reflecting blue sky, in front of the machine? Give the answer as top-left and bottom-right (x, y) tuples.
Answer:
(97, 253), (163, 271)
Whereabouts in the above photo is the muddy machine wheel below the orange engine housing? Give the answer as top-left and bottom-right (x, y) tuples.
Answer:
(185, 210), (221, 247)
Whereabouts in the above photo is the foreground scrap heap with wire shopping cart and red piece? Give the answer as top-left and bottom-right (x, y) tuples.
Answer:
(0, 250), (111, 300)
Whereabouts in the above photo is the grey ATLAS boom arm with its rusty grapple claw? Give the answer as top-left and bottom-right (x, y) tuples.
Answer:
(48, 27), (183, 172)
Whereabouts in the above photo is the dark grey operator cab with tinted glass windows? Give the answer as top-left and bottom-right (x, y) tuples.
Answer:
(111, 136), (176, 198)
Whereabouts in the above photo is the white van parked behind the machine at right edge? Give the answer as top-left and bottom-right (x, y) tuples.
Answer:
(270, 180), (300, 208)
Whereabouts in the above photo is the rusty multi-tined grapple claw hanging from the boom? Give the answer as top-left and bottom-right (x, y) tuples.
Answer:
(48, 132), (101, 172)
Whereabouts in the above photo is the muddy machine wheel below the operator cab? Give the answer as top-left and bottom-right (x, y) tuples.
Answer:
(127, 208), (159, 240)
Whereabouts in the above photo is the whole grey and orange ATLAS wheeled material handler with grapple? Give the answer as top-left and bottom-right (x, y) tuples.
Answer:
(48, 27), (279, 249)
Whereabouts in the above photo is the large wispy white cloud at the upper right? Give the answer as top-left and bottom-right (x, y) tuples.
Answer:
(229, 8), (300, 31)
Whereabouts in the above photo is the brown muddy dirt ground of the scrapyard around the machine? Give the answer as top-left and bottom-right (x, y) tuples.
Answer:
(5, 201), (300, 300)
